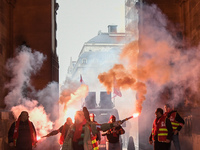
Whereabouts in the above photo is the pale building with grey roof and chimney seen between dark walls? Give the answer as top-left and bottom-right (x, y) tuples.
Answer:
(68, 25), (125, 103)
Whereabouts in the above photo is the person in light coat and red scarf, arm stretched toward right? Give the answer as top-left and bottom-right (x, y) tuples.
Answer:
(62, 107), (121, 150)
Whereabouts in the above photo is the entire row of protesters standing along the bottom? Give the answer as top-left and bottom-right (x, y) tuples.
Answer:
(8, 104), (184, 150)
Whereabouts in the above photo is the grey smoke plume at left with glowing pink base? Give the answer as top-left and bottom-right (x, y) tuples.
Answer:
(5, 46), (59, 149)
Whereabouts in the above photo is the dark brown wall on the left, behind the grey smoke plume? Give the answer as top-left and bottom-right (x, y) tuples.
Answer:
(0, 0), (59, 150)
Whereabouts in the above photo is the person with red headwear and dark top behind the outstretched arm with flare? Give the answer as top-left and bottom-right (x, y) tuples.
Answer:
(102, 115), (125, 150)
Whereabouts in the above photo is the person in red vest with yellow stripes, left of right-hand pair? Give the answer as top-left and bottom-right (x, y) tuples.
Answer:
(149, 108), (173, 150)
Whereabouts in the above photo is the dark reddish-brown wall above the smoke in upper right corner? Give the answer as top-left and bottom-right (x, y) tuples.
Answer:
(139, 0), (200, 46)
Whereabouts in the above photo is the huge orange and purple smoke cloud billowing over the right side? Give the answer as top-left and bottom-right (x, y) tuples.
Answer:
(99, 5), (200, 112)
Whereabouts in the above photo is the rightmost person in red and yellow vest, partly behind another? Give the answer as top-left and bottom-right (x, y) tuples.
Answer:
(164, 104), (185, 150)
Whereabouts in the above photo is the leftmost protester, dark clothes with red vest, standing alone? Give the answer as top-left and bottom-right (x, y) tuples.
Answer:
(8, 111), (37, 150)
